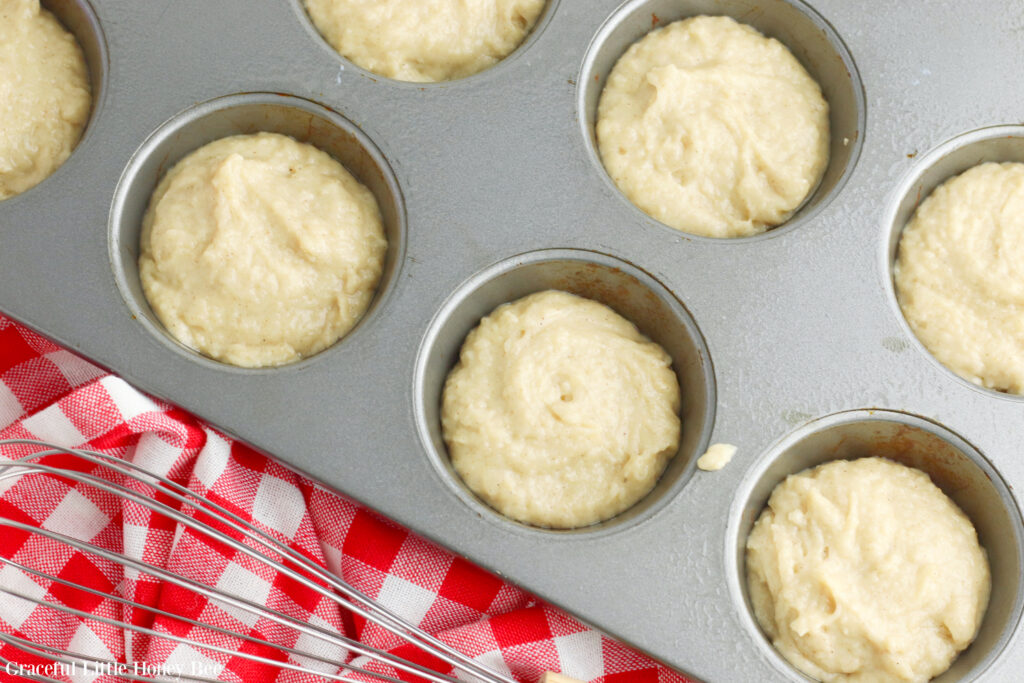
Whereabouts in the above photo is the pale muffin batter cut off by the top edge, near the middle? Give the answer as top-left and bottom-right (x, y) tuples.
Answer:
(306, 0), (545, 82)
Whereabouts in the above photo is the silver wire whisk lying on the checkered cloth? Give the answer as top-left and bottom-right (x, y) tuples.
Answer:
(0, 439), (515, 683)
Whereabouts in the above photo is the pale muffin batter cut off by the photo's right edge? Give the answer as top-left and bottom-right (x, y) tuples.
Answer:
(895, 163), (1024, 394)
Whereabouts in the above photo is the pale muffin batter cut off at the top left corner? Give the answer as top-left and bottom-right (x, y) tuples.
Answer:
(0, 0), (92, 200)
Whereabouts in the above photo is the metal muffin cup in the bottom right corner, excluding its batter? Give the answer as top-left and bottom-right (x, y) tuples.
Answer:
(726, 410), (1024, 683)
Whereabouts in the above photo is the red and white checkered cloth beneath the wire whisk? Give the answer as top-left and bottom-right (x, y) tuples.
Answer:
(0, 316), (686, 683)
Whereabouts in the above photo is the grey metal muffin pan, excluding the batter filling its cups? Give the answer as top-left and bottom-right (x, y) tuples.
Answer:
(6, 0), (1024, 681)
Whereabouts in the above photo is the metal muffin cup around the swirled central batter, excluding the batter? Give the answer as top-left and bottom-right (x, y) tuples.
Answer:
(414, 249), (715, 535)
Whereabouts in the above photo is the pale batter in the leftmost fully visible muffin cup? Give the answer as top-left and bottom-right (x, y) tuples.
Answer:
(139, 133), (387, 368)
